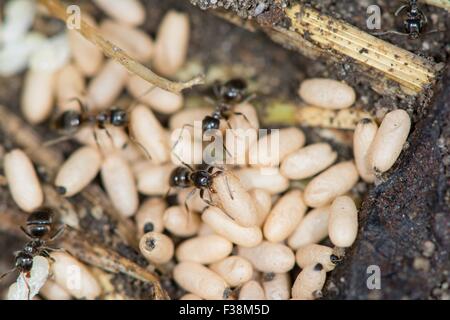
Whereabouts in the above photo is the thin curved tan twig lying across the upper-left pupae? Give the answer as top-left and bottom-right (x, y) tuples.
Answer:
(39, 0), (204, 93)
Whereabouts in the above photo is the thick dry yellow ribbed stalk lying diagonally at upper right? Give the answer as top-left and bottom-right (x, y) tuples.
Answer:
(286, 4), (437, 94)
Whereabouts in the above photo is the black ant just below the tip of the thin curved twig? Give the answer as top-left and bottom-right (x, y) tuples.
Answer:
(172, 78), (253, 156)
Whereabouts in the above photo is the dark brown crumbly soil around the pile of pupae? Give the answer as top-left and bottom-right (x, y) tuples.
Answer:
(0, 0), (450, 299)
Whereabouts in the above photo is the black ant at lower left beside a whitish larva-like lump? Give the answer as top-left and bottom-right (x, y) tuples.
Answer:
(0, 208), (65, 298)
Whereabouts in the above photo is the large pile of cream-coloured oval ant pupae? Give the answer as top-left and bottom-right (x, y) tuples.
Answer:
(0, 0), (410, 299)
